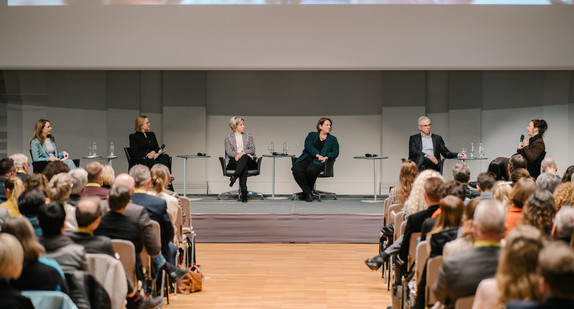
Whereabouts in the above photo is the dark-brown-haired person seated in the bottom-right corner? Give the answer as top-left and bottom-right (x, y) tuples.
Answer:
(506, 242), (574, 309)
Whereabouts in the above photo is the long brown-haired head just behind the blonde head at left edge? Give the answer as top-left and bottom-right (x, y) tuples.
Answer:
(2, 217), (44, 266)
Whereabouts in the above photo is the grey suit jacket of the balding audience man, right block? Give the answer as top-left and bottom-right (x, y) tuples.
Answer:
(433, 247), (500, 308)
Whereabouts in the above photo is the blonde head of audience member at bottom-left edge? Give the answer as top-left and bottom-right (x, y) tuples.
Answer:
(0, 233), (24, 280)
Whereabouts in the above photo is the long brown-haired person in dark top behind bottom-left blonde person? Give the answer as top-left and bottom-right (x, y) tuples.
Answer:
(2, 217), (68, 293)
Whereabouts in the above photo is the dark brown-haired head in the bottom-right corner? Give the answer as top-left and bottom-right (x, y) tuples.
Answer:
(538, 241), (574, 299)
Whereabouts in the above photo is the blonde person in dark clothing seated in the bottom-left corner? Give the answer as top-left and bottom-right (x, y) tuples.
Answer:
(0, 233), (34, 309)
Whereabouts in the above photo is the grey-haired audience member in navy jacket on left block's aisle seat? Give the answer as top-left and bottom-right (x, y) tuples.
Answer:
(130, 164), (177, 264)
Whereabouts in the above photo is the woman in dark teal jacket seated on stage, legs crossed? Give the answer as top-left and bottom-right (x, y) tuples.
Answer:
(291, 117), (339, 202)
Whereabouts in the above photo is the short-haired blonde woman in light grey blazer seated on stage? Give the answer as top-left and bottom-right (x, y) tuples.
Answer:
(225, 116), (257, 203)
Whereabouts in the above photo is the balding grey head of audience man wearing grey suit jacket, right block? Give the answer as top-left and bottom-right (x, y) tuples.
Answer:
(473, 199), (506, 240)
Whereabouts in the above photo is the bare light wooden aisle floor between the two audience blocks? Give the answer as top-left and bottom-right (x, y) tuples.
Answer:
(164, 243), (391, 309)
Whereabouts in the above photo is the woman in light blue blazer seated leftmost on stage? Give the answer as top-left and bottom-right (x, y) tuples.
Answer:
(30, 119), (76, 169)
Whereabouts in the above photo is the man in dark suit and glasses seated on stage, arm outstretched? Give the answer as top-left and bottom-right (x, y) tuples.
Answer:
(409, 116), (466, 171)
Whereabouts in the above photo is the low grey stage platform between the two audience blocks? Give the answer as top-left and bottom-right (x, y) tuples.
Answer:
(188, 195), (386, 244)
